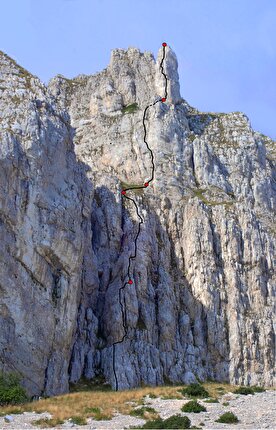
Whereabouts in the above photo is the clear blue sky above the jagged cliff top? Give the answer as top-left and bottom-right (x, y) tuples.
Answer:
(0, 0), (276, 139)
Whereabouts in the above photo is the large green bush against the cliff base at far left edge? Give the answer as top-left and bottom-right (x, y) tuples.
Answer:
(0, 373), (28, 406)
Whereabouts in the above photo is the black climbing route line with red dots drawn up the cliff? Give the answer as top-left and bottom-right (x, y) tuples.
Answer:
(112, 42), (168, 391)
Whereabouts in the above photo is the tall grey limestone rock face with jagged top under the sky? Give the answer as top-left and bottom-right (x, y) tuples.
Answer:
(0, 47), (276, 395)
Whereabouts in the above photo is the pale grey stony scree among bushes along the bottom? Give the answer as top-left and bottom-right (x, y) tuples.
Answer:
(0, 391), (276, 430)
